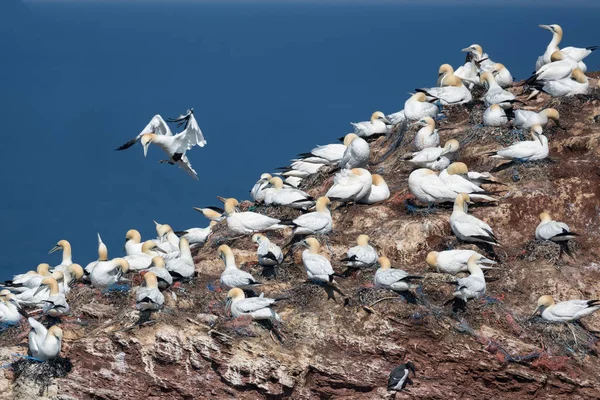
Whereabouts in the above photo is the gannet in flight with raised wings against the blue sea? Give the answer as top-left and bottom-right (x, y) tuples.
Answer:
(117, 109), (206, 179)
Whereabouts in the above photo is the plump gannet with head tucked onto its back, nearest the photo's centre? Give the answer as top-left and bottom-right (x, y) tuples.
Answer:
(325, 168), (373, 202)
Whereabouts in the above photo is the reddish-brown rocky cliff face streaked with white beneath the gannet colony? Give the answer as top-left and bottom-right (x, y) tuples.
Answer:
(0, 74), (600, 400)
